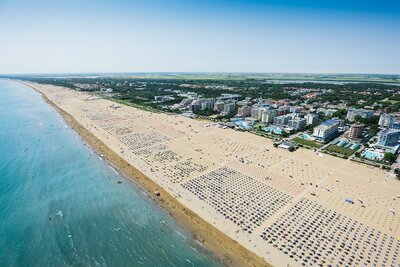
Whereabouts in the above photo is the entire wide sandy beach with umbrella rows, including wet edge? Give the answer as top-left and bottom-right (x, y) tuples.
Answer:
(24, 82), (400, 266)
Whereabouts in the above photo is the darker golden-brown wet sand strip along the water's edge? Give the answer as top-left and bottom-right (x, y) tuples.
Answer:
(22, 80), (272, 266)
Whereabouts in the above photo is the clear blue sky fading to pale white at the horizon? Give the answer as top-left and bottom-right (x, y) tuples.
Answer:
(0, 0), (400, 74)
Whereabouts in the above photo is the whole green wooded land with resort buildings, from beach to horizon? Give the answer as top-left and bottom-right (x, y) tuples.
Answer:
(17, 77), (400, 178)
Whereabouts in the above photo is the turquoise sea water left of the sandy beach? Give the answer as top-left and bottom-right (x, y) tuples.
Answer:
(0, 80), (221, 267)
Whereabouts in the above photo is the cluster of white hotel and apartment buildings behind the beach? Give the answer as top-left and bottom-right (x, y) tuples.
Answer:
(159, 89), (400, 176)
